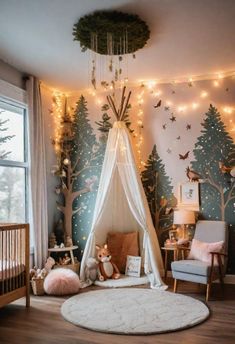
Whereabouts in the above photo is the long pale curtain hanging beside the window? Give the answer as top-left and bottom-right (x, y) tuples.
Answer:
(26, 76), (48, 267)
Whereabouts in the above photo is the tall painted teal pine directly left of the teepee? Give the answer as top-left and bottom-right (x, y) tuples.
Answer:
(71, 96), (103, 260)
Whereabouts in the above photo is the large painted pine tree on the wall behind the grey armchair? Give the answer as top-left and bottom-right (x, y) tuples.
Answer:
(191, 105), (235, 272)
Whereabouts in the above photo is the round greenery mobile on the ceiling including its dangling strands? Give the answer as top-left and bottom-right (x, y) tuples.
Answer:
(73, 11), (150, 88)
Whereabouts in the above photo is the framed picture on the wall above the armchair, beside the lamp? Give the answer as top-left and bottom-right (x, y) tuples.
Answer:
(177, 182), (199, 211)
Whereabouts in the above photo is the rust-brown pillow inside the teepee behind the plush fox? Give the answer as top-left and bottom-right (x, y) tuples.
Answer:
(107, 231), (139, 273)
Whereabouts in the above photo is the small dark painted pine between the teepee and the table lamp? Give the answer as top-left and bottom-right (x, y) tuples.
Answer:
(141, 145), (176, 240)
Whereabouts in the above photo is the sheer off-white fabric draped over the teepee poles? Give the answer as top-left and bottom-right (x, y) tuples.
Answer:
(80, 121), (166, 289)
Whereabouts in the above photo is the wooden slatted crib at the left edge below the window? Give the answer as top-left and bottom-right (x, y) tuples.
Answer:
(0, 224), (30, 307)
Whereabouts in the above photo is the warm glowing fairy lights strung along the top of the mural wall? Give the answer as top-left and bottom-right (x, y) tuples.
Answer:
(52, 72), (235, 170)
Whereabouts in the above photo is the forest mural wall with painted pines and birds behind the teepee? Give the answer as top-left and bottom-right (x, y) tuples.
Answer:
(45, 77), (235, 274)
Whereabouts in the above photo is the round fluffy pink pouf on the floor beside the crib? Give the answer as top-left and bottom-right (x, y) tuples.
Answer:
(44, 268), (80, 295)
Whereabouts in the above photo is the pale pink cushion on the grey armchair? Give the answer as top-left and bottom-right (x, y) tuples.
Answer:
(187, 239), (224, 265)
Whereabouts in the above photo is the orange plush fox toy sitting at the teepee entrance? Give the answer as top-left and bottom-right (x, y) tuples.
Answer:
(96, 244), (120, 281)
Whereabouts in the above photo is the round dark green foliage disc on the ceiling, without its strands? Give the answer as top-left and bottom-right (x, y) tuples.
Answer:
(73, 11), (150, 55)
